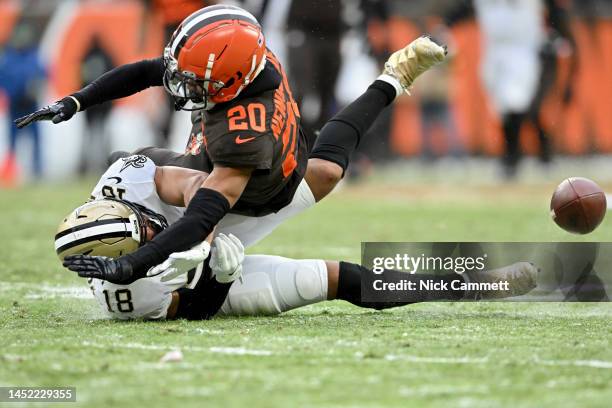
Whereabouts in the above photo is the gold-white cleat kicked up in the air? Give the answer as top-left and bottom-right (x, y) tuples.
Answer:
(383, 37), (446, 94)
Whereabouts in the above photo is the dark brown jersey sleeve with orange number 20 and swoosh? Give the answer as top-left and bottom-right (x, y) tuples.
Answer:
(204, 98), (274, 171)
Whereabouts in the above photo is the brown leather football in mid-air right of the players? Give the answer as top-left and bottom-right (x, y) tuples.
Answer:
(550, 177), (607, 234)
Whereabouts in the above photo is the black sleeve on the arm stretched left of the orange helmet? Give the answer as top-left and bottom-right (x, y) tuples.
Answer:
(72, 57), (165, 110)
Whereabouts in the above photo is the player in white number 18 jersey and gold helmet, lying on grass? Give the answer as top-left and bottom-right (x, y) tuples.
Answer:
(55, 156), (536, 319)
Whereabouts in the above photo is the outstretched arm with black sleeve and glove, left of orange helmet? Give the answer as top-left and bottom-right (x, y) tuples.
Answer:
(15, 57), (165, 128)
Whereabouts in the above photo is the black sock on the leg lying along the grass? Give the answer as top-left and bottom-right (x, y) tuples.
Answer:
(336, 262), (465, 310)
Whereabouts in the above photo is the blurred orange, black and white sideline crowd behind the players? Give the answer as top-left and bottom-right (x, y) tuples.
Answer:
(0, 0), (612, 185)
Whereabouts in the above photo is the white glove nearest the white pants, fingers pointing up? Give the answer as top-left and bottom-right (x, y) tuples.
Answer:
(210, 234), (244, 283)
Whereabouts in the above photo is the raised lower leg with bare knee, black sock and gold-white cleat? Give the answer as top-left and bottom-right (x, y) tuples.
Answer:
(305, 37), (446, 201)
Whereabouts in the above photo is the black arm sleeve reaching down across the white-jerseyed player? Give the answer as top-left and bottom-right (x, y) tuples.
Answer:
(120, 188), (230, 279)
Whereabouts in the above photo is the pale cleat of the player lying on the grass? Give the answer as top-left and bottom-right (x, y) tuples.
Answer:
(462, 262), (539, 300)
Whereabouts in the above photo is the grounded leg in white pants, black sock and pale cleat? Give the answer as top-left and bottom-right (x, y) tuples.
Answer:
(220, 255), (537, 316)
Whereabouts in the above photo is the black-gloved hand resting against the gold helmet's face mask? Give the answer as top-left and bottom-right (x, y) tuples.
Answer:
(63, 255), (134, 285)
